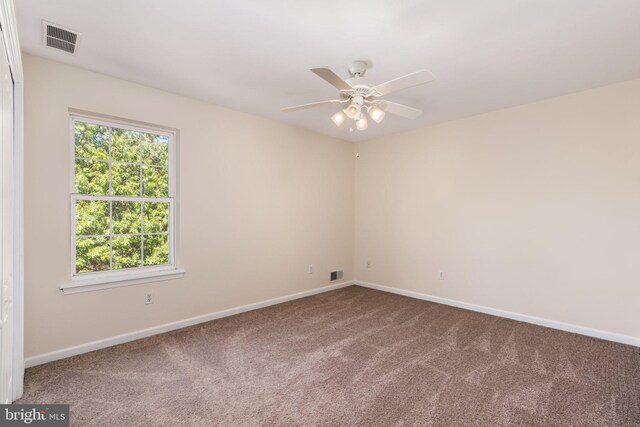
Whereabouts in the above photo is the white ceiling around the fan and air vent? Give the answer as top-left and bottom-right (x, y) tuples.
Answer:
(16, 0), (640, 141)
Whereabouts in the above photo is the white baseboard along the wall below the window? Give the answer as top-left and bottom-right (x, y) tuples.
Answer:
(24, 280), (354, 368)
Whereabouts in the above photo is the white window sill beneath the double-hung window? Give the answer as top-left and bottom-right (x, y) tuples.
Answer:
(60, 267), (186, 295)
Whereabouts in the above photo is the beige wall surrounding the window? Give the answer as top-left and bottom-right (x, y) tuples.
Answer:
(24, 55), (354, 357)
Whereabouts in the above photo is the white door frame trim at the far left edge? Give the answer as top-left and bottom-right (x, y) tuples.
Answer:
(0, 0), (24, 400)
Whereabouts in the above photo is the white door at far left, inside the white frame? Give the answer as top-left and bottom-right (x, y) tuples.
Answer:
(0, 25), (14, 403)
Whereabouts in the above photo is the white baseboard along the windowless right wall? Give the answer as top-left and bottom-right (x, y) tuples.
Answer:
(355, 280), (640, 347)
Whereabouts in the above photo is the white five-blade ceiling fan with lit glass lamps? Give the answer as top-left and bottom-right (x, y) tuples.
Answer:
(282, 61), (435, 130)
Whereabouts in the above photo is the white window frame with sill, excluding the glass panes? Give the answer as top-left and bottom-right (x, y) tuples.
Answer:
(61, 113), (185, 294)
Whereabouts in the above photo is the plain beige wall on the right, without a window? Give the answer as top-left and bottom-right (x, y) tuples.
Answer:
(355, 80), (640, 337)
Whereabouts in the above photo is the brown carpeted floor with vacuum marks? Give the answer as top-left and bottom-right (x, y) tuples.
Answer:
(17, 286), (640, 427)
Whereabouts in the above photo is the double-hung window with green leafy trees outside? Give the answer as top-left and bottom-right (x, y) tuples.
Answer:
(63, 116), (182, 289)
